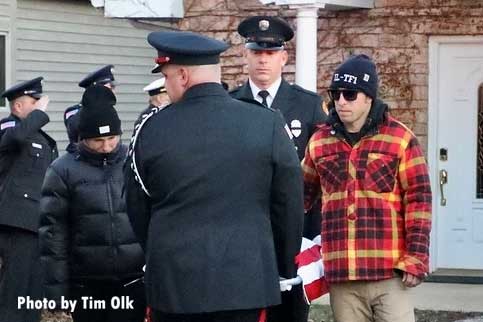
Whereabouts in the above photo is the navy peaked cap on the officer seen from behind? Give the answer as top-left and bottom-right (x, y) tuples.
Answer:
(148, 31), (229, 72)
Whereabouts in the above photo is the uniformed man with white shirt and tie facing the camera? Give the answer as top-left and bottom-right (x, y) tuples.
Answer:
(230, 16), (326, 322)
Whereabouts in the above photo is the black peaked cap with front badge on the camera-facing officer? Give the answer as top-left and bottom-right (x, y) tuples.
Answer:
(238, 16), (294, 50)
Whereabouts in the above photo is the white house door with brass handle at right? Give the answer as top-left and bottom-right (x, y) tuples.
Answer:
(429, 39), (483, 270)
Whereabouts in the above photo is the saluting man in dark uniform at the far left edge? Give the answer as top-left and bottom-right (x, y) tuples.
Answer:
(0, 77), (57, 322)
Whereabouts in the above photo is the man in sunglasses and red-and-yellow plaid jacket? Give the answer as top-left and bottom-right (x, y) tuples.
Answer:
(302, 55), (431, 322)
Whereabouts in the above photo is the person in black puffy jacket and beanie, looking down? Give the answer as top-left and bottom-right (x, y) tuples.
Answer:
(39, 85), (145, 322)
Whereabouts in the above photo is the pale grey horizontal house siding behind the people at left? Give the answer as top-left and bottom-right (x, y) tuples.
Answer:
(15, 0), (161, 151)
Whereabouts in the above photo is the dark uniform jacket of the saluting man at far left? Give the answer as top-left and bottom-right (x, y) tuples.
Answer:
(0, 110), (58, 232)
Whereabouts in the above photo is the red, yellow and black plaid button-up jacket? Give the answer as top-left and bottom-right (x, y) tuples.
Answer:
(302, 112), (431, 282)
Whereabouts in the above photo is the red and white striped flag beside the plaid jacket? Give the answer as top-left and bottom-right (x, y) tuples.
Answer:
(295, 235), (329, 304)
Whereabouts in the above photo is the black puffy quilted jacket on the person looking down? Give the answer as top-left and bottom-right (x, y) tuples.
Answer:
(39, 144), (144, 300)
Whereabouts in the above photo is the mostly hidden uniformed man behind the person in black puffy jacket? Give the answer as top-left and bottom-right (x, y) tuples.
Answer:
(64, 65), (117, 153)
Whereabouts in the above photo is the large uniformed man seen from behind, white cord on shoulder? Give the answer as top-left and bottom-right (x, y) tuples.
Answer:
(125, 32), (303, 322)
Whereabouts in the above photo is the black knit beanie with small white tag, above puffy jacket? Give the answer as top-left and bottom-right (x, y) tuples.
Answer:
(79, 85), (122, 140)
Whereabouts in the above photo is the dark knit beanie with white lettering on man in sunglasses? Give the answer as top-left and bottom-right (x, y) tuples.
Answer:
(330, 55), (379, 99)
